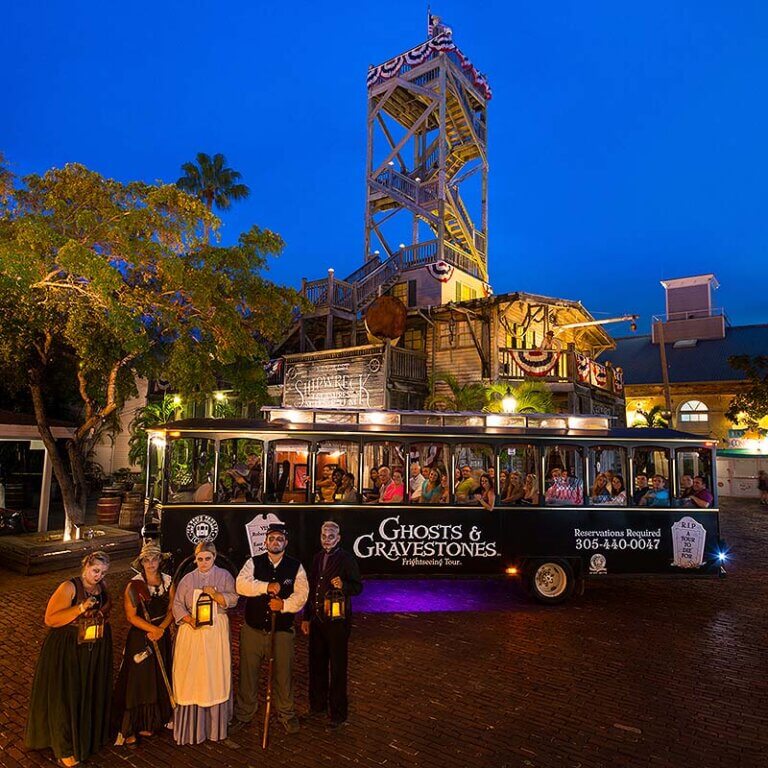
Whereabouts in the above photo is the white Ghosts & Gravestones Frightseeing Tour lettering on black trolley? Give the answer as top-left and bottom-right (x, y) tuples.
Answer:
(353, 515), (501, 567)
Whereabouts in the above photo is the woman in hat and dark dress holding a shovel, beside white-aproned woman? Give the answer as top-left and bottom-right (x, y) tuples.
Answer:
(113, 541), (173, 747)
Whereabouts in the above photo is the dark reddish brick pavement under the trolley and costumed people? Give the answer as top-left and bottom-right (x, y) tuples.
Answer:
(0, 501), (768, 768)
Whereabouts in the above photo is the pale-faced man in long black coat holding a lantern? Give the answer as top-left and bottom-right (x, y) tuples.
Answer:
(301, 521), (363, 728)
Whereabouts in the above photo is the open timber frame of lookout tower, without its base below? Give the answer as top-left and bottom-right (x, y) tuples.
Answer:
(365, 16), (491, 298)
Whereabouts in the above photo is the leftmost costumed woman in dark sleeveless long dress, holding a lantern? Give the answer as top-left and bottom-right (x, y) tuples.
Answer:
(25, 551), (112, 768)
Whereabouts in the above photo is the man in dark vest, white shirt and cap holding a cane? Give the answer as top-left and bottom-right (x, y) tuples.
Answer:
(229, 524), (309, 733)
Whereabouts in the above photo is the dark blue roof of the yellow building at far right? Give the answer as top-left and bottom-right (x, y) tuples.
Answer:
(606, 324), (768, 385)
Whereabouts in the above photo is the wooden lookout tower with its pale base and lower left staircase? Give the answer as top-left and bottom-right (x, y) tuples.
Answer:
(280, 16), (491, 352)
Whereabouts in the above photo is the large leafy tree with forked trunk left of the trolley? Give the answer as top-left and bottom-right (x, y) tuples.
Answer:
(0, 160), (299, 530)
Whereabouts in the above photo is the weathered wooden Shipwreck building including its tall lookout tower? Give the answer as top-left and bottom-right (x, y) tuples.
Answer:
(271, 23), (624, 423)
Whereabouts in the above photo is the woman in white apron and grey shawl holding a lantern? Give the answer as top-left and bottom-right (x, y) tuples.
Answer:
(173, 541), (237, 744)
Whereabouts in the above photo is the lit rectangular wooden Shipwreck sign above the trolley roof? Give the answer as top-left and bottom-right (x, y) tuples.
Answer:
(283, 346), (386, 408)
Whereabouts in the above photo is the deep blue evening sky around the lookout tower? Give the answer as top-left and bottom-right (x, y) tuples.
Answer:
(6, 0), (768, 335)
